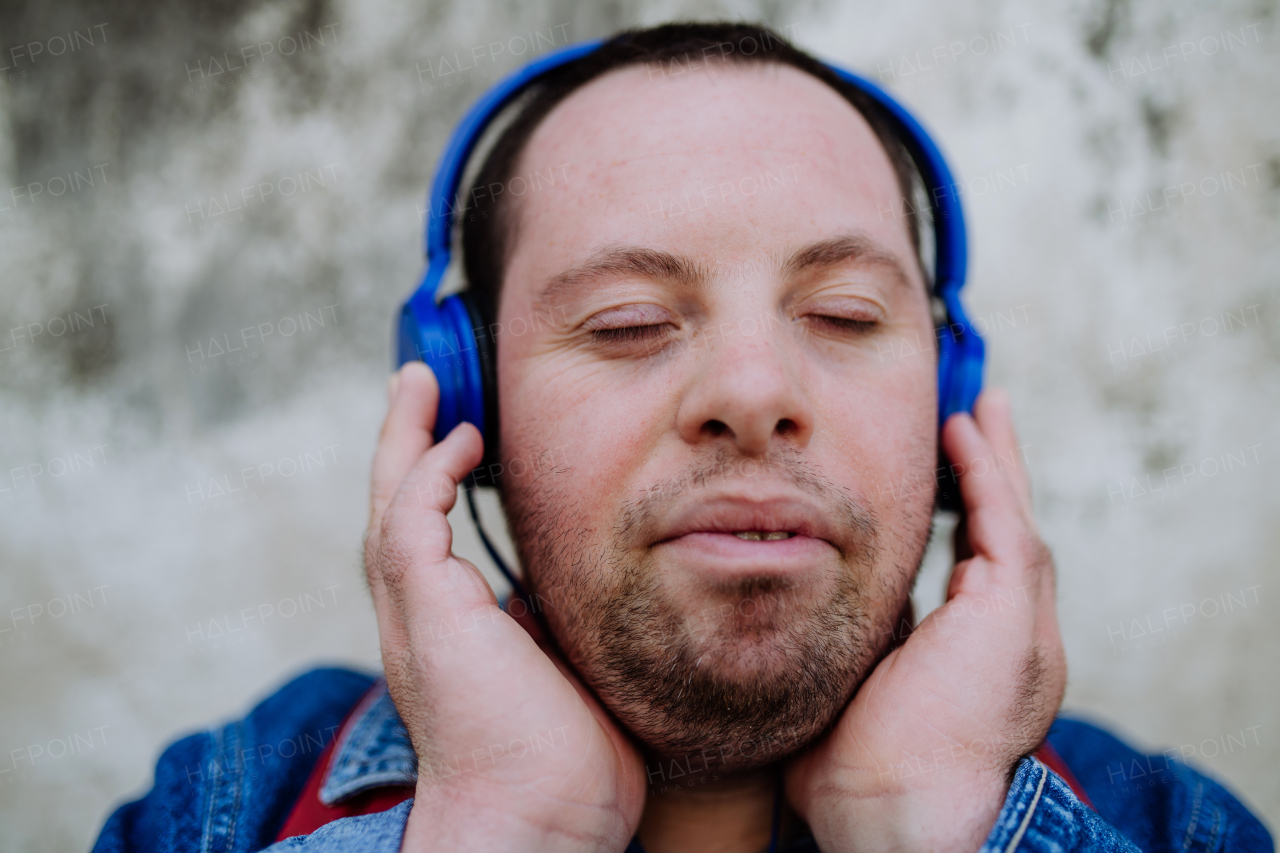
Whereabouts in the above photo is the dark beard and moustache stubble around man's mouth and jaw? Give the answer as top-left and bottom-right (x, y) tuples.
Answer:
(502, 438), (929, 771)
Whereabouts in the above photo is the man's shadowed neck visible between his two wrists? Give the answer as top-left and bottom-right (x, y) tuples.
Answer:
(639, 767), (780, 853)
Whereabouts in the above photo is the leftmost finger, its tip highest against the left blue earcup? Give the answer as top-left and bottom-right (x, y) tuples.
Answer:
(369, 361), (440, 532)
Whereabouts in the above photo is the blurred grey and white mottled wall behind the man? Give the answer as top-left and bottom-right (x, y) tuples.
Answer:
(0, 0), (1280, 850)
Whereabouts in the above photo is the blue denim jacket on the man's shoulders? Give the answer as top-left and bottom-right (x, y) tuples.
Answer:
(93, 669), (1275, 853)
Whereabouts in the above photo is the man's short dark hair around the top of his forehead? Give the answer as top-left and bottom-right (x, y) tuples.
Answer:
(462, 23), (924, 324)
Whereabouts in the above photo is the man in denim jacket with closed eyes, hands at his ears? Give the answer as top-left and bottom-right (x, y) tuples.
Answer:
(96, 24), (1271, 853)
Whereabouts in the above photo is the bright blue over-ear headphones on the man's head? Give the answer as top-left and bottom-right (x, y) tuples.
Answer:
(396, 40), (984, 484)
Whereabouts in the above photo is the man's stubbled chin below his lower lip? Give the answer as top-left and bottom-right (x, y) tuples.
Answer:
(564, 563), (887, 771)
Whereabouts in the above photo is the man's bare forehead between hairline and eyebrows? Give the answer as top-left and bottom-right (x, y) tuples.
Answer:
(504, 63), (915, 291)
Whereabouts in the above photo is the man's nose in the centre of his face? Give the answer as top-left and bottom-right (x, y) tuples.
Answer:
(677, 315), (814, 456)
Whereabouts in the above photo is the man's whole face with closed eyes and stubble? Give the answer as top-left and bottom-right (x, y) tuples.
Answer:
(498, 59), (937, 768)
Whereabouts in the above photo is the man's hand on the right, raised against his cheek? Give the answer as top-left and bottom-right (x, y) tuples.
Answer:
(786, 392), (1066, 853)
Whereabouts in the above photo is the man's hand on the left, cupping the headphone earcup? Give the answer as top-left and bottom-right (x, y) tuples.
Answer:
(365, 361), (645, 852)
